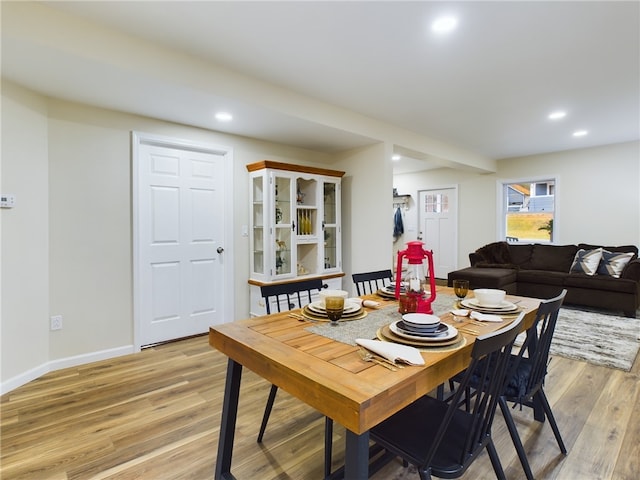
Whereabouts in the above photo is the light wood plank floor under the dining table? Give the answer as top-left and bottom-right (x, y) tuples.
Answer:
(0, 336), (640, 480)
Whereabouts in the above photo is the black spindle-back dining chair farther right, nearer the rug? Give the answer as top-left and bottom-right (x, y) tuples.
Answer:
(453, 290), (567, 480)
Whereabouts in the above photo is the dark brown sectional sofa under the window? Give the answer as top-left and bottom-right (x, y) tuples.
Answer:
(448, 242), (640, 317)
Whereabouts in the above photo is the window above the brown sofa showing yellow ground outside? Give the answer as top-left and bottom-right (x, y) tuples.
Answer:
(500, 178), (556, 243)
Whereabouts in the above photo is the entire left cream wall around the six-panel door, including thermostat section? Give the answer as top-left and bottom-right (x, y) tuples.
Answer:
(1, 82), (333, 391)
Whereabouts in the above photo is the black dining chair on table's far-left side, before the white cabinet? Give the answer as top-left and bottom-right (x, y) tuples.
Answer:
(258, 279), (333, 478)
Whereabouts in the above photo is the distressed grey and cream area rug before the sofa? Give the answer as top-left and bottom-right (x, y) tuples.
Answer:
(433, 294), (640, 372)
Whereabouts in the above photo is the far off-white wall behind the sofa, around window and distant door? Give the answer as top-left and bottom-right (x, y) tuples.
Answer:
(393, 142), (640, 268)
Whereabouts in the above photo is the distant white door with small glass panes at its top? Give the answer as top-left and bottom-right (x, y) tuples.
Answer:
(418, 187), (458, 278)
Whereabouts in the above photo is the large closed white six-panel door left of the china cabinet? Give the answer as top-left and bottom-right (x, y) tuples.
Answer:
(134, 133), (232, 347)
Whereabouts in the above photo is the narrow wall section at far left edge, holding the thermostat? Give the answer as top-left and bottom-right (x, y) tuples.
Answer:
(0, 82), (49, 386)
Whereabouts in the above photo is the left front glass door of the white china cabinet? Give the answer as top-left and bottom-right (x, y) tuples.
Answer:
(273, 174), (295, 276)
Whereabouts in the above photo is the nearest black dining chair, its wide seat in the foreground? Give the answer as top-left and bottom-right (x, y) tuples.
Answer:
(370, 313), (524, 480)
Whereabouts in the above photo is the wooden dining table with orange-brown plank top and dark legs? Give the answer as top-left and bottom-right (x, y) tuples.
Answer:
(209, 287), (540, 480)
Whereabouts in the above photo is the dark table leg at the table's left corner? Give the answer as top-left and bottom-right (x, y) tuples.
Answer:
(214, 359), (242, 480)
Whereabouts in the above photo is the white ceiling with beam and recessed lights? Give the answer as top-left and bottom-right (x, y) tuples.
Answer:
(2, 1), (640, 171)
